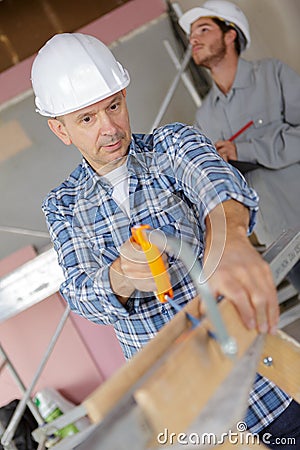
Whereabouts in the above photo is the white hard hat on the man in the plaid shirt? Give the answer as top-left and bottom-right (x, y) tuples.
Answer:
(31, 33), (130, 117)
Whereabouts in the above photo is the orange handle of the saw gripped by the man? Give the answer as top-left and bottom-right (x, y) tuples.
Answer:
(130, 225), (174, 303)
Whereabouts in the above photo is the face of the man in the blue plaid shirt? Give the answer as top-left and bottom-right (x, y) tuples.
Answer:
(49, 90), (131, 175)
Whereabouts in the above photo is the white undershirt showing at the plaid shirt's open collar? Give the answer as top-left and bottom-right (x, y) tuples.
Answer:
(103, 163), (130, 217)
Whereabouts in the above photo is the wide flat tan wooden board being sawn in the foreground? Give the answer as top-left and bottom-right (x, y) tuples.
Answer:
(134, 302), (256, 435)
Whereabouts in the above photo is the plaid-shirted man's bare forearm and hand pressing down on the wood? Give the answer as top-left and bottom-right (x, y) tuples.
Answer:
(204, 200), (278, 333)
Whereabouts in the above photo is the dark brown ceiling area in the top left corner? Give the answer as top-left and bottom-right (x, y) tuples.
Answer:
(0, 0), (130, 72)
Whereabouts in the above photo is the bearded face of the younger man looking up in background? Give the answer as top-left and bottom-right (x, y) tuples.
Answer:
(190, 17), (226, 69)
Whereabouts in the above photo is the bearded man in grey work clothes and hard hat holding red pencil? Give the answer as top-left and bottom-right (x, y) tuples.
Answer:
(179, 0), (300, 292)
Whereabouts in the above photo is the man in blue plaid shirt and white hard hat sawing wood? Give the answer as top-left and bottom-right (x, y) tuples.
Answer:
(32, 33), (289, 446)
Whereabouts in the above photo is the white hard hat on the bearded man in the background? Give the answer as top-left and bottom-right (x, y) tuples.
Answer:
(179, 0), (251, 51)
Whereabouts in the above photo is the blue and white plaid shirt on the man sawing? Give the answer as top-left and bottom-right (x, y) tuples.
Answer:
(43, 123), (289, 432)
